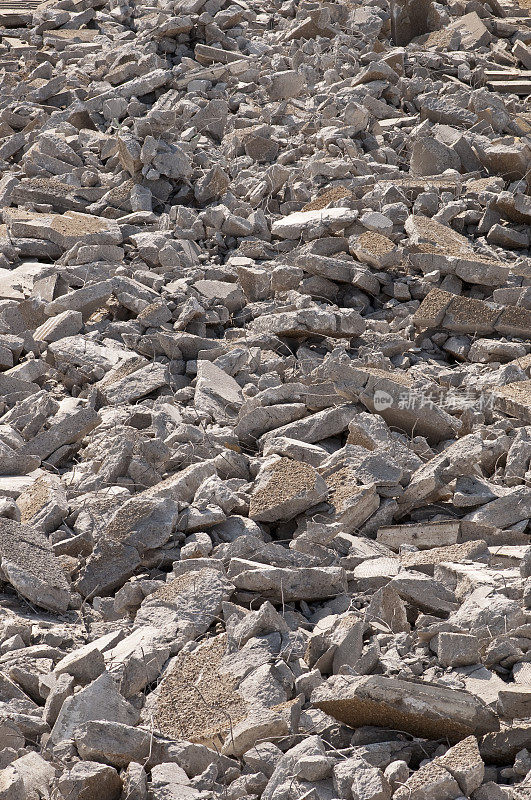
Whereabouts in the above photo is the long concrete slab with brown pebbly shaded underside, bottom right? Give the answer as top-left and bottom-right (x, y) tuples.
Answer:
(311, 675), (499, 742)
